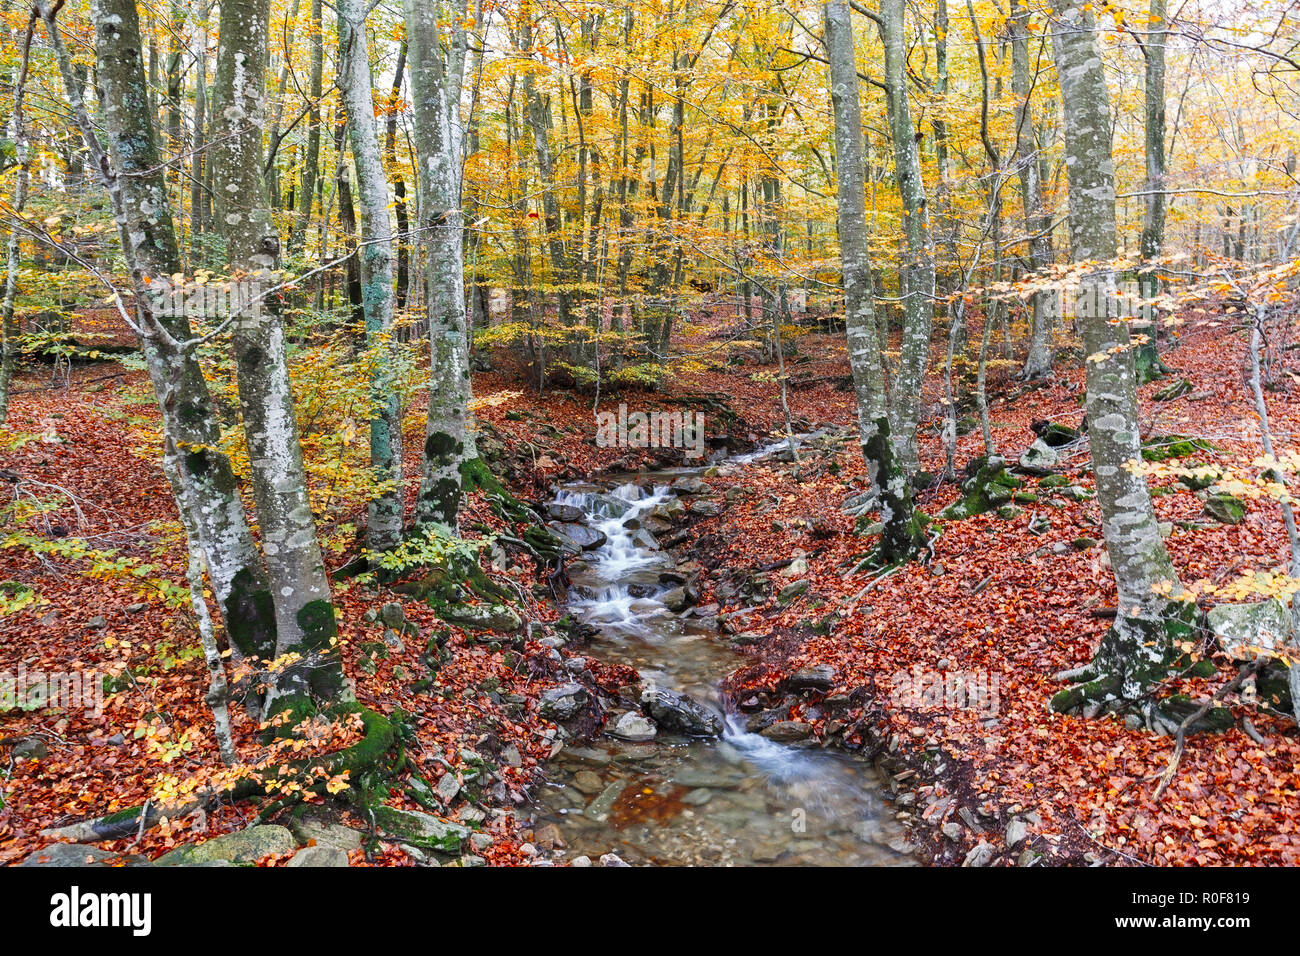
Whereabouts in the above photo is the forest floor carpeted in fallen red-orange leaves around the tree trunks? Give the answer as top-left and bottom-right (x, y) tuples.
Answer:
(0, 303), (1300, 865)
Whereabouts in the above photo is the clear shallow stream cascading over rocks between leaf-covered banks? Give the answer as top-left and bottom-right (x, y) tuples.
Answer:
(537, 449), (910, 865)
